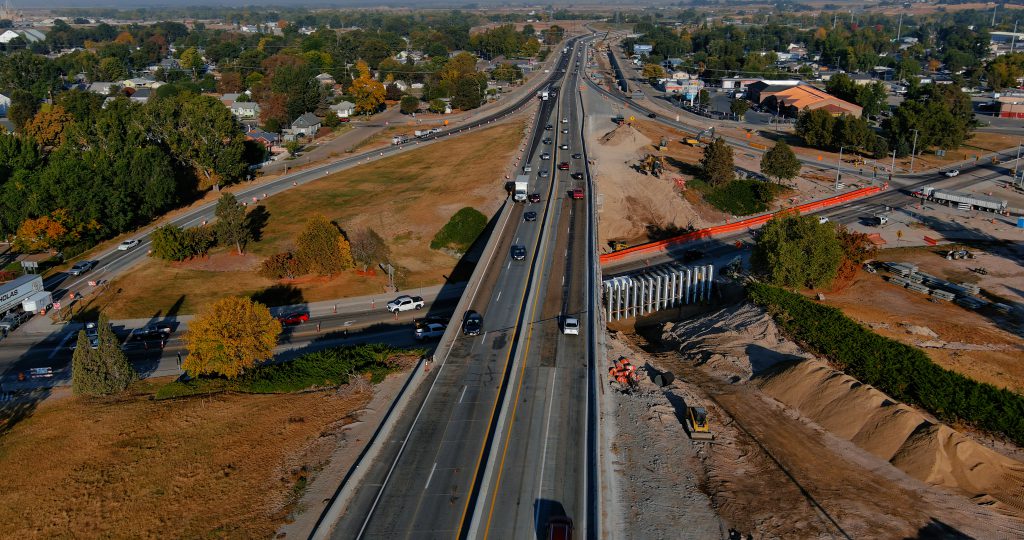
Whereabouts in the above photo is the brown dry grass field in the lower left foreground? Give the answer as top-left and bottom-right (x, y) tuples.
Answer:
(0, 380), (371, 538)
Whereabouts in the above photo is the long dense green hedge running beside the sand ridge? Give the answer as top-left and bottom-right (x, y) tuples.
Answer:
(748, 283), (1024, 445)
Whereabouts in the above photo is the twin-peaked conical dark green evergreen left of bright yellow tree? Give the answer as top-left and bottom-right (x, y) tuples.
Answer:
(72, 315), (138, 396)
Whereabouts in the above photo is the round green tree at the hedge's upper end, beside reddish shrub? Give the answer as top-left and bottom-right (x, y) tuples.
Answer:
(751, 214), (843, 288)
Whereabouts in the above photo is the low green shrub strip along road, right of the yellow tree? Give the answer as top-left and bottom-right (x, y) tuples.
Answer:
(157, 343), (416, 400)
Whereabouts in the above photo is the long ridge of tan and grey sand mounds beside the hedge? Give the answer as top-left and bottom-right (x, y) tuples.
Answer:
(664, 304), (1024, 515)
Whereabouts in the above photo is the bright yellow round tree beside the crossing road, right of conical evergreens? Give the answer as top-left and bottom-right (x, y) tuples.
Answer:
(181, 296), (281, 378)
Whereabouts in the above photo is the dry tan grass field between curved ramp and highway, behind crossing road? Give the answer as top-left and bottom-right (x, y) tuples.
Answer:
(89, 122), (524, 319)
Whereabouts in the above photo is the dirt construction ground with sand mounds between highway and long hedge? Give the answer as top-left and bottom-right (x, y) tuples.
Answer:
(600, 291), (1024, 538)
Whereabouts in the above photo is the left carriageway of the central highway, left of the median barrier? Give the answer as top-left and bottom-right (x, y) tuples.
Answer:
(323, 40), (584, 538)
